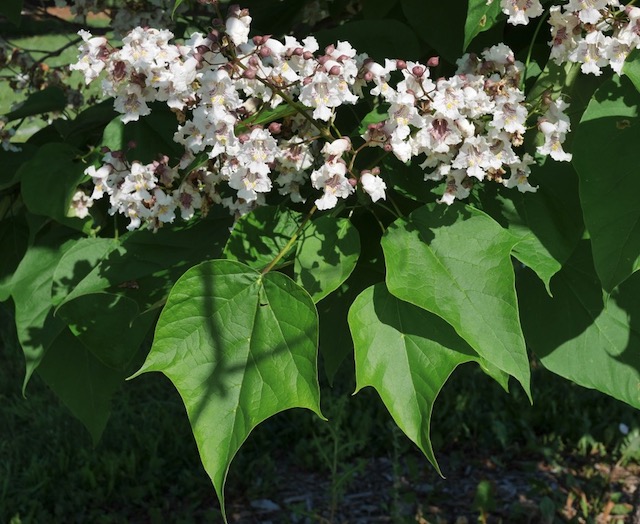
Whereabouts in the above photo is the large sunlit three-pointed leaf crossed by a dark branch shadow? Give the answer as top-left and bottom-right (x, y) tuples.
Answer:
(136, 260), (322, 513)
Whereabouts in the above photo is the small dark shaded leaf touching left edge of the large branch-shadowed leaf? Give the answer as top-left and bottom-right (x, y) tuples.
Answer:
(56, 293), (156, 372)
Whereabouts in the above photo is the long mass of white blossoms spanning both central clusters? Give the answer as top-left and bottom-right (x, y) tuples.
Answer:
(73, 6), (569, 229)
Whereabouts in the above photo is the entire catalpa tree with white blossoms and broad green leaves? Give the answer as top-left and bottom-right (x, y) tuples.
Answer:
(0, 0), (640, 513)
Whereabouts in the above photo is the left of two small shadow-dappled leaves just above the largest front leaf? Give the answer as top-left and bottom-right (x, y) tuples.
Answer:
(224, 206), (302, 269)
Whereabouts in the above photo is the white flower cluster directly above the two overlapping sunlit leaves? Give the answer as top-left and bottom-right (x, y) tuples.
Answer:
(366, 44), (571, 204)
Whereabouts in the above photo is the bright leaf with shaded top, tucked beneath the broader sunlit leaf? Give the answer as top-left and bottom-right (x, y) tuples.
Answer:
(349, 284), (496, 474)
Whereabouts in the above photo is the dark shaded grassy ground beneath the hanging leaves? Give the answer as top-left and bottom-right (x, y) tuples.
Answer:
(0, 294), (640, 524)
